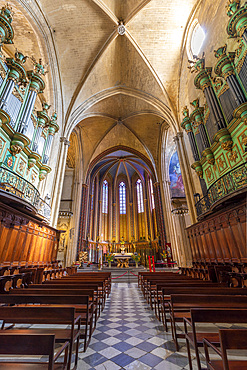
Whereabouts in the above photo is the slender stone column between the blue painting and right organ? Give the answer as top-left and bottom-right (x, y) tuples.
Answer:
(173, 132), (197, 223)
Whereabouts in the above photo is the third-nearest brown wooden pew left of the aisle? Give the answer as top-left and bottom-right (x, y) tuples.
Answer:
(0, 294), (93, 351)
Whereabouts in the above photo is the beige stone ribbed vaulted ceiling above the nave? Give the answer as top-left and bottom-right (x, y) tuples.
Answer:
(11, 0), (200, 173)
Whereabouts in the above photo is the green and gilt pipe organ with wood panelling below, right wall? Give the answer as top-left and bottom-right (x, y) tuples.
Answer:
(181, 2), (247, 271)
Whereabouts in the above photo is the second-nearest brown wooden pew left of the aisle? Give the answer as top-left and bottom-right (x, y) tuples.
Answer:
(0, 306), (81, 369)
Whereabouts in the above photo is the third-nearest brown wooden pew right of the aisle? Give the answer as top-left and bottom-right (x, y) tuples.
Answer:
(168, 294), (247, 351)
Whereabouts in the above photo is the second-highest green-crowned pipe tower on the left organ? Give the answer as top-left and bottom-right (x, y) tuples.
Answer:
(0, 51), (27, 110)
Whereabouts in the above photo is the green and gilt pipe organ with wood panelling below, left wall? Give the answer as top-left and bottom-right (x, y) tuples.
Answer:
(0, 5), (59, 263)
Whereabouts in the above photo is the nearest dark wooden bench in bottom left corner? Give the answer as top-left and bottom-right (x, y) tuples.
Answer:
(0, 331), (69, 370)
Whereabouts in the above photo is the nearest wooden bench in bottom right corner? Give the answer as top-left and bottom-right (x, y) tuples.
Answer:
(203, 329), (247, 370)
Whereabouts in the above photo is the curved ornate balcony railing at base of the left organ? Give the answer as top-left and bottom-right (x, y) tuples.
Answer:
(0, 166), (51, 220)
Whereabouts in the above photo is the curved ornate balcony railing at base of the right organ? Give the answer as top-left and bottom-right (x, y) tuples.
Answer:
(195, 163), (247, 217)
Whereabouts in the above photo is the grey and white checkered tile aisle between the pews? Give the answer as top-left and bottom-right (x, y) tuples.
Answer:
(78, 283), (194, 370)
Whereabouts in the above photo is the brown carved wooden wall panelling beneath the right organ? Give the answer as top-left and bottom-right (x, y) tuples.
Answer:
(187, 201), (247, 262)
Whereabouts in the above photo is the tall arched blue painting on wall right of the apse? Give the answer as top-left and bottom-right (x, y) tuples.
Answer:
(169, 152), (185, 198)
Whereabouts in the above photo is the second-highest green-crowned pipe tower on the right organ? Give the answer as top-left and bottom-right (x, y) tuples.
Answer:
(214, 45), (246, 105)
